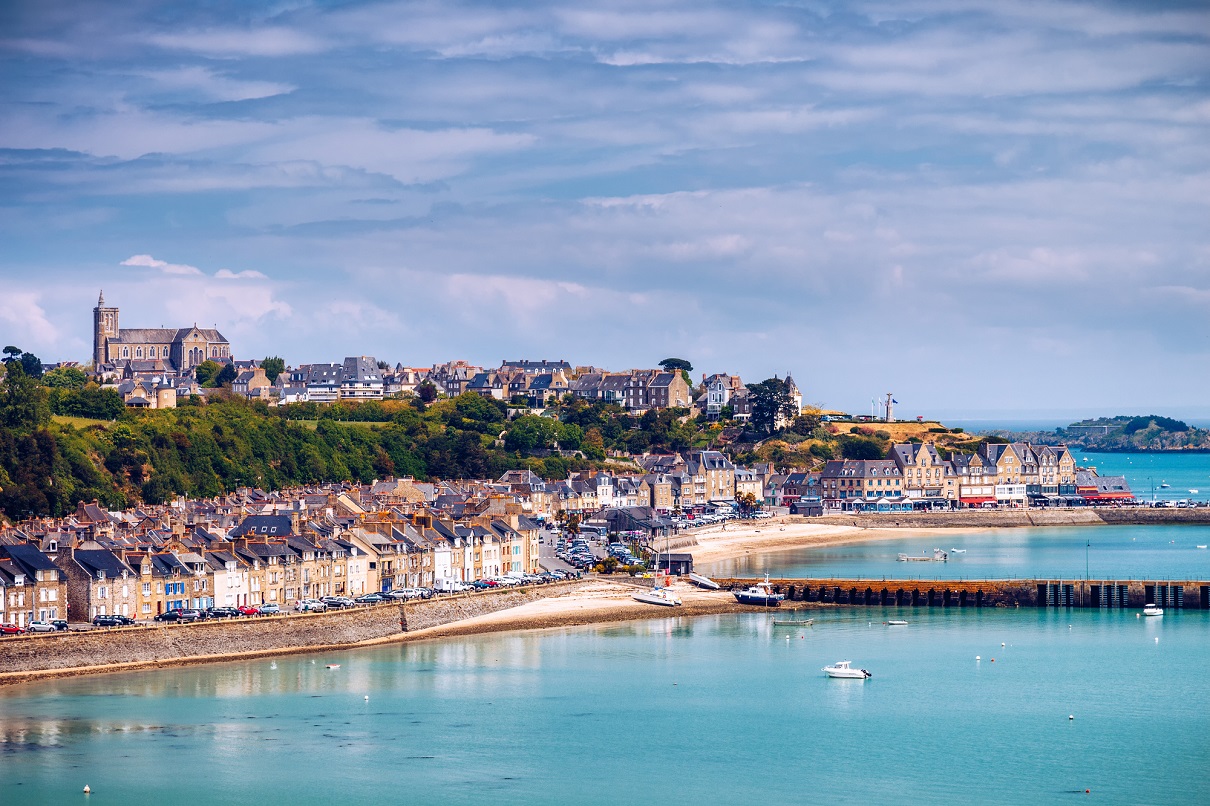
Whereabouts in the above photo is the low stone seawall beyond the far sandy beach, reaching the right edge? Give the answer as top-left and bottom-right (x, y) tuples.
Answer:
(799, 507), (1210, 529)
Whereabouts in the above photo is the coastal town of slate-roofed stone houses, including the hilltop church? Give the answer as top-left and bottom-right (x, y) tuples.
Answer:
(0, 297), (1156, 629)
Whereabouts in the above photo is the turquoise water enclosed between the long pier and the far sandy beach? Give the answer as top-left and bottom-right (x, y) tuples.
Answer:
(699, 525), (1210, 580)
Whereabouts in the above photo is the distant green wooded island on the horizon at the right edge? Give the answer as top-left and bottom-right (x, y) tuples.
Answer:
(992, 414), (1210, 453)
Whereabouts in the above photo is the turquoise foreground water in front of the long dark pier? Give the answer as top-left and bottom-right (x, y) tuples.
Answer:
(0, 609), (1210, 806)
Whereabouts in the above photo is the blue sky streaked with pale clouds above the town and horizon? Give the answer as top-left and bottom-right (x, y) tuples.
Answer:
(0, 0), (1210, 416)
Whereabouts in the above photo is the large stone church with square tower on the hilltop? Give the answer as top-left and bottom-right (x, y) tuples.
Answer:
(92, 292), (231, 374)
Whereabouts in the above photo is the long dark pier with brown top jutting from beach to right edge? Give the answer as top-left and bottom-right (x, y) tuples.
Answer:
(715, 577), (1210, 610)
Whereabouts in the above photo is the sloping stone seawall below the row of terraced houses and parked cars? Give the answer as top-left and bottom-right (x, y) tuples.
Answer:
(0, 581), (581, 685)
